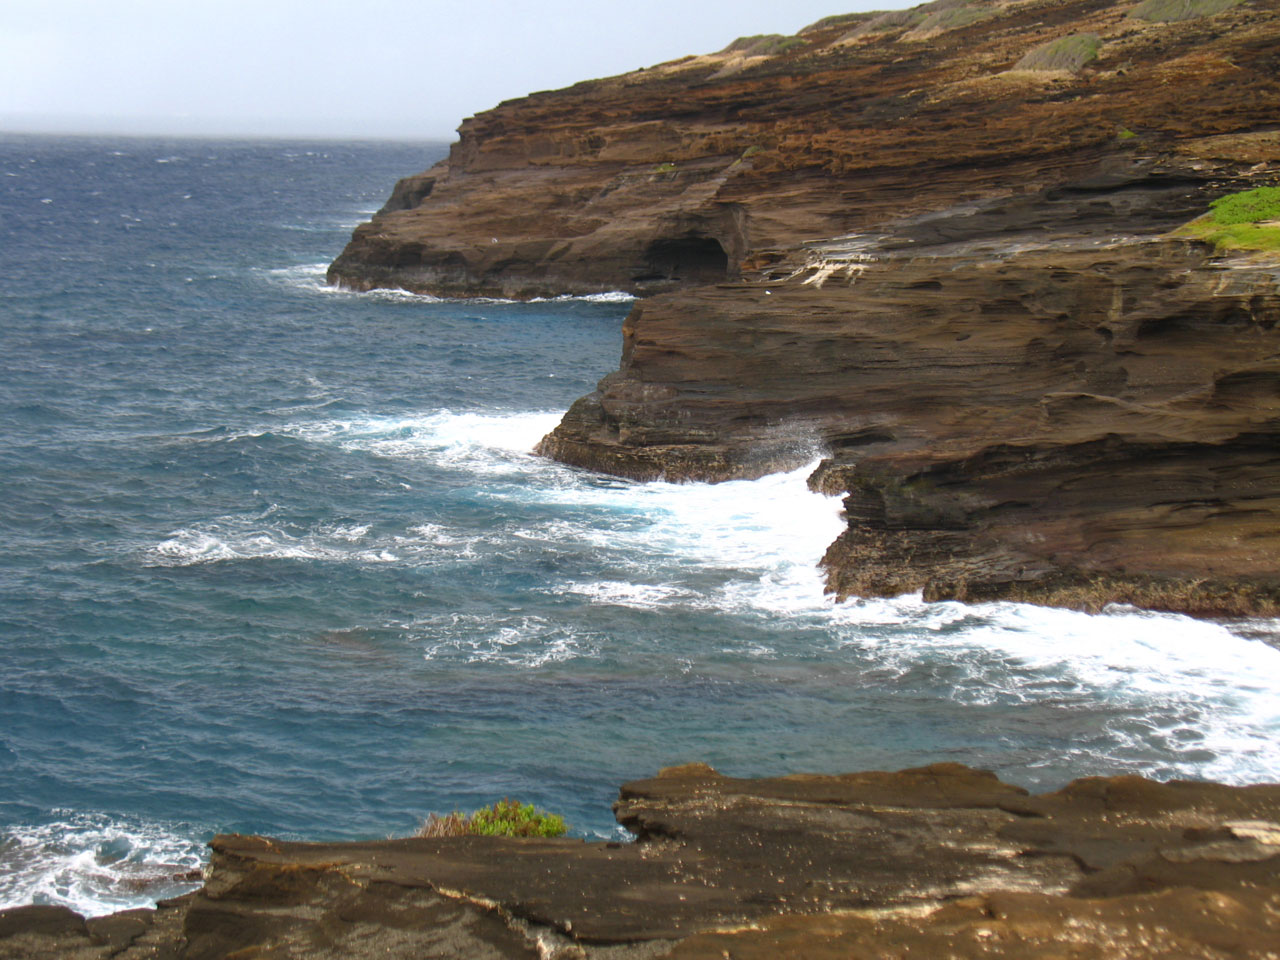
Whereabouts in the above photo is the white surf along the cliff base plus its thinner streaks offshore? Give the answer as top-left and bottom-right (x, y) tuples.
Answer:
(142, 411), (1280, 782)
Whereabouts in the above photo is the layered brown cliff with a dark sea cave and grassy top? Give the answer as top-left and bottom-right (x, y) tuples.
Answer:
(329, 0), (1280, 616)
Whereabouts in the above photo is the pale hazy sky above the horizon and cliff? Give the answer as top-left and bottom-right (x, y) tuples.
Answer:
(0, 0), (909, 140)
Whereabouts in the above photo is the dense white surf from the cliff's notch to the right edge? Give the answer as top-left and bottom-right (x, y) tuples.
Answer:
(503, 455), (1280, 782)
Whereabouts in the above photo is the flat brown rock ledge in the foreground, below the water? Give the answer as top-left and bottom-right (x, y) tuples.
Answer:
(0, 764), (1280, 960)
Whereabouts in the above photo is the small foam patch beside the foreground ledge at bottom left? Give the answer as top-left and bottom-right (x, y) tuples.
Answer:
(0, 813), (205, 916)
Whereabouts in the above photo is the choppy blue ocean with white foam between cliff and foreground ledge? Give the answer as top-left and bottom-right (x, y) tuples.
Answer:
(0, 136), (1280, 913)
